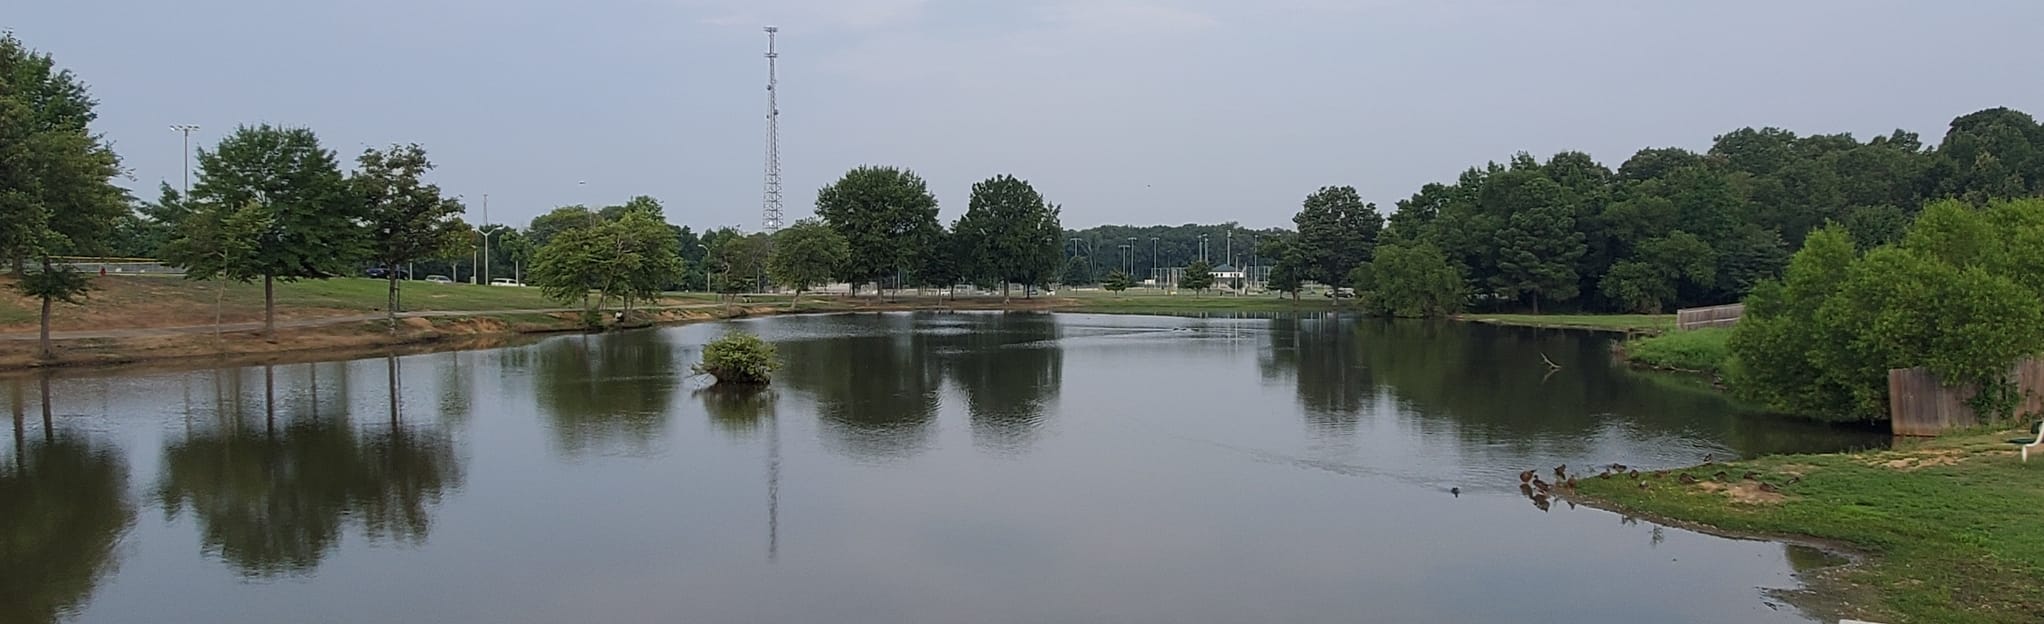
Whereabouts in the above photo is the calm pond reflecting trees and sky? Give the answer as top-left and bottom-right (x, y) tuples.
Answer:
(0, 313), (1885, 624)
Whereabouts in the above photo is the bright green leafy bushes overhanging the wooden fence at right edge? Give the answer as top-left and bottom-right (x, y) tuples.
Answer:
(1725, 198), (2044, 421)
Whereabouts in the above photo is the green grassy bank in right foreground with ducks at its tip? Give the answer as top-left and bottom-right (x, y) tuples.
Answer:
(1576, 432), (2044, 622)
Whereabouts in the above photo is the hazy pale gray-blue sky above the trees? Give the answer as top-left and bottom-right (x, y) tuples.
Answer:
(15, 0), (2044, 229)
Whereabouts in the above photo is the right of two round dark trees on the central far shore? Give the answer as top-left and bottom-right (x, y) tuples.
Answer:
(953, 176), (1065, 297)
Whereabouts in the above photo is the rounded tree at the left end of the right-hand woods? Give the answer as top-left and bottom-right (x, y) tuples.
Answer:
(1290, 186), (1384, 284)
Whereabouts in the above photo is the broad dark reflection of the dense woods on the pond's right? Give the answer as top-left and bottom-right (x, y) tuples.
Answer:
(1259, 317), (1885, 456)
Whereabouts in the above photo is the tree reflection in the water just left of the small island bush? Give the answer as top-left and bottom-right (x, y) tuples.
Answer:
(525, 331), (683, 456)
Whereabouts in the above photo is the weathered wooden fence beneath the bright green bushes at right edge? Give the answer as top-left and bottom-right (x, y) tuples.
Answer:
(1889, 358), (2044, 436)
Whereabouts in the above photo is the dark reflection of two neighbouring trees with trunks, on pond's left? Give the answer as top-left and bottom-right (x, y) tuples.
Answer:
(155, 360), (462, 577)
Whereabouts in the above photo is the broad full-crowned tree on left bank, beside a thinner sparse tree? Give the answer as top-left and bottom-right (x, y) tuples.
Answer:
(166, 125), (366, 340)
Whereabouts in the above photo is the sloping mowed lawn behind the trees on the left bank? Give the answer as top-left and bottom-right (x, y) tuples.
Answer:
(0, 276), (713, 331)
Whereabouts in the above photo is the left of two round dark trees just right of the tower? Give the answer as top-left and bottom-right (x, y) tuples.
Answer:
(816, 166), (940, 288)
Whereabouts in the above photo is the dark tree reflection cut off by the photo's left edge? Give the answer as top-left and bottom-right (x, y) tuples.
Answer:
(0, 378), (135, 624)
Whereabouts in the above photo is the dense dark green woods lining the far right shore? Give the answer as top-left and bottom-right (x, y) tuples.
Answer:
(1265, 108), (2044, 313)
